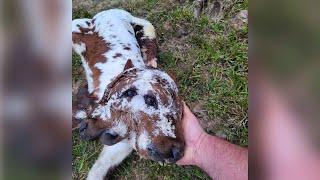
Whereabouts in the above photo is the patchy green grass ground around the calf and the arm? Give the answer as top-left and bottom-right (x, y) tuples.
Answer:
(72, 0), (248, 179)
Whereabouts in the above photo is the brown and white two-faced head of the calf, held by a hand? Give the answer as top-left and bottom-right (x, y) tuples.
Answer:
(80, 67), (184, 163)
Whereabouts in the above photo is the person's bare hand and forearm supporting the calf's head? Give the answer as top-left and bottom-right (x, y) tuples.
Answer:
(177, 104), (248, 180)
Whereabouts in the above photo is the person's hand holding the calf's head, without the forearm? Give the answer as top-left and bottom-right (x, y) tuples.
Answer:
(177, 102), (206, 165)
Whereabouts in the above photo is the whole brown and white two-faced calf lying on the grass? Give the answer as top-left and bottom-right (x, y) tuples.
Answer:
(72, 9), (184, 179)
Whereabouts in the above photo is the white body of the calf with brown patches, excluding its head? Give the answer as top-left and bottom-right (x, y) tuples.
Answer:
(72, 9), (157, 102)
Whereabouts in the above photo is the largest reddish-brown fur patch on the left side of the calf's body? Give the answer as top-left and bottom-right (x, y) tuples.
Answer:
(72, 27), (110, 96)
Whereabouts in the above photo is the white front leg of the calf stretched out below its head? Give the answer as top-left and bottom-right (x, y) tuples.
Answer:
(87, 139), (132, 180)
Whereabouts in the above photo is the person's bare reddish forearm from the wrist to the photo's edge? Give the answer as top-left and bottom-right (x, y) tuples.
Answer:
(194, 133), (248, 180)
